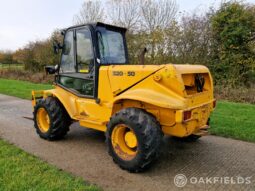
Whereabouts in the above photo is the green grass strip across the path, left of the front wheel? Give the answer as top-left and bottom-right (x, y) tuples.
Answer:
(0, 78), (52, 99)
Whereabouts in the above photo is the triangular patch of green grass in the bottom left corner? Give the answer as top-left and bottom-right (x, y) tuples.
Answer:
(0, 140), (99, 191)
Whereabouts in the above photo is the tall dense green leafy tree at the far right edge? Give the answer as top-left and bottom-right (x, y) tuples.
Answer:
(211, 1), (255, 85)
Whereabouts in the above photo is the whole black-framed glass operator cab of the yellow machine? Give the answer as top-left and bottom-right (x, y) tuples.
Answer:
(52, 23), (128, 98)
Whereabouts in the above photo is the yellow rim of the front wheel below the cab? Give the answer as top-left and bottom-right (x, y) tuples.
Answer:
(36, 108), (50, 133)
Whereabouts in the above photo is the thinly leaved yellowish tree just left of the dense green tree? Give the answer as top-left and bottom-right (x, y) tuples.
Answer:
(165, 13), (211, 65)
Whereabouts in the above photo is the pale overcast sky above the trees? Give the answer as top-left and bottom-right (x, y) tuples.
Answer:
(0, 0), (255, 50)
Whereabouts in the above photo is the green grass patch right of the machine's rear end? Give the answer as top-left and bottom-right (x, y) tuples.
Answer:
(210, 101), (255, 142)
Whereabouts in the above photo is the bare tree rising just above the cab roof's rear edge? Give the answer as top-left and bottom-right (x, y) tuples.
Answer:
(108, 0), (141, 30)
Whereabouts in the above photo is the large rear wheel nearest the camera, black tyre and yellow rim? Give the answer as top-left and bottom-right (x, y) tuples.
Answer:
(106, 108), (163, 172)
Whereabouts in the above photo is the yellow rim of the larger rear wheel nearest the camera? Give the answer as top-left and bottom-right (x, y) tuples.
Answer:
(111, 124), (138, 160)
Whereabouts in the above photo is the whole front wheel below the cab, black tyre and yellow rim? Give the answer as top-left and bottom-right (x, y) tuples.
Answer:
(33, 97), (71, 141)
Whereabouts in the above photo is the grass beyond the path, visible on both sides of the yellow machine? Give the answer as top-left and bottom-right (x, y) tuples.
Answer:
(0, 79), (255, 142)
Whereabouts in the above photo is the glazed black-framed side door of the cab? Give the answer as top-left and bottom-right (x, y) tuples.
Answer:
(57, 27), (96, 98)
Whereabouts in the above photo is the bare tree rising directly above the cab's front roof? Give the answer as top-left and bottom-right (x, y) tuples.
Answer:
(73, 0), (105, 24)
